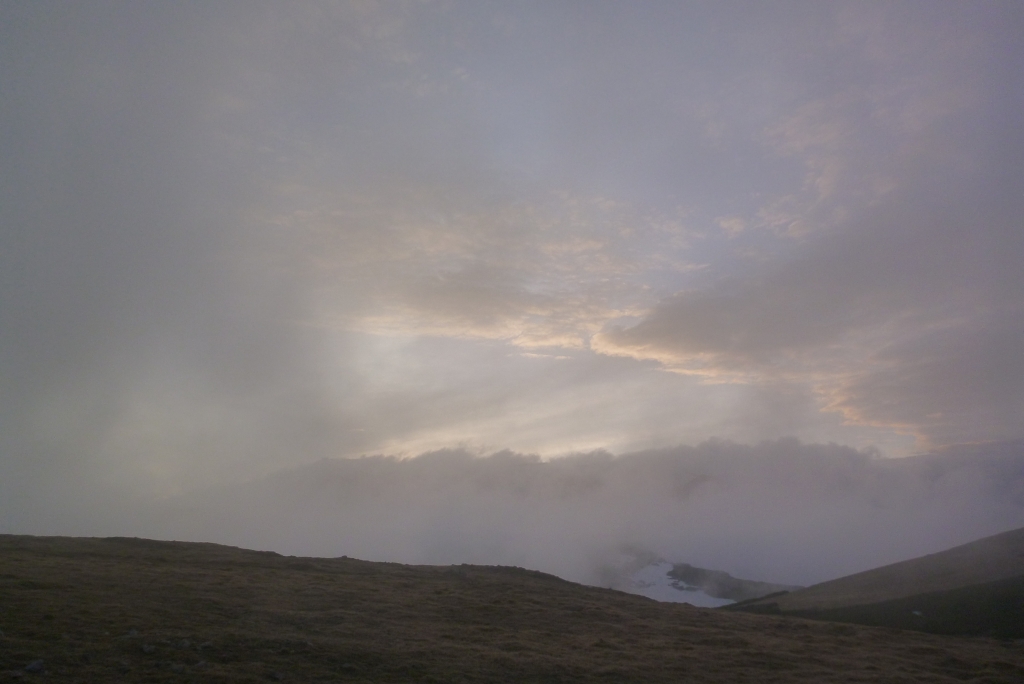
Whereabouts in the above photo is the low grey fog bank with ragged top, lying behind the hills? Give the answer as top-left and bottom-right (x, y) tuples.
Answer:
(12, 439), (1024, 585)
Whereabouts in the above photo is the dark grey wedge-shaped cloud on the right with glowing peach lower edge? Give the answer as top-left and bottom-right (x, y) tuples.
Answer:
(592, 154), (1024, 444)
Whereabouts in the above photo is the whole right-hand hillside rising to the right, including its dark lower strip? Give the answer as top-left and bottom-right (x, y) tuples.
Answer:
(729, 528), (1024, 638)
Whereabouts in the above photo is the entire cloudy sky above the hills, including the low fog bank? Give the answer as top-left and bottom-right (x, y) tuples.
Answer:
(6, 0), (1024, 583)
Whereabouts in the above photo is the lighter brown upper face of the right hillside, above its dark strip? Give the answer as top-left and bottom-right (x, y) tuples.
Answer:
(729, 527), (1024, 612)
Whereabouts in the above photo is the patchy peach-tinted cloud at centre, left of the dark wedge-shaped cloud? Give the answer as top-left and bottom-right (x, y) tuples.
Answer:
(278, 181), (694, 349)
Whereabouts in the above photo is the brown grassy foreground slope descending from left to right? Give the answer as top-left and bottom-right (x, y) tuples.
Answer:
(0, 536), (1024, 682)
